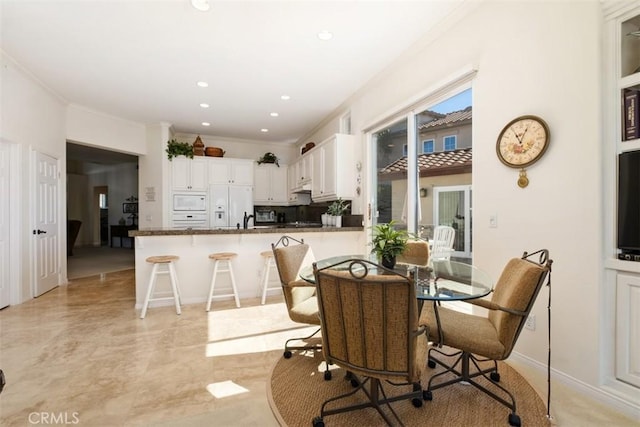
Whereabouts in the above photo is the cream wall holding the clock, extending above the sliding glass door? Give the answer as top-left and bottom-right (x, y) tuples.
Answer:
(309, 0), (624, 412)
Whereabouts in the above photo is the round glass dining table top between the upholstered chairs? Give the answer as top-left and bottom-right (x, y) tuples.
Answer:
(299, 254), (494, 342)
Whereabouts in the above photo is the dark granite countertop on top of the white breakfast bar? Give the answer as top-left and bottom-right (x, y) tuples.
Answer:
(129, 225), (364, 237)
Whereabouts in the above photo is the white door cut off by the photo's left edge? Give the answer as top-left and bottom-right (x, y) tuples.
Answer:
(0, 142), (11, 308)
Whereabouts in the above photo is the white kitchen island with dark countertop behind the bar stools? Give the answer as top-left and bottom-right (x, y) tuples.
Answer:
(129, 226), (367, 310)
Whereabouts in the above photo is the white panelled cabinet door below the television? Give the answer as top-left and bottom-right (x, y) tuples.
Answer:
(616, 274), (640, 387)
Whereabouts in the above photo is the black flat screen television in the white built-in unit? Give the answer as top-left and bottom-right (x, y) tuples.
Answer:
(618, 150), (640, 255)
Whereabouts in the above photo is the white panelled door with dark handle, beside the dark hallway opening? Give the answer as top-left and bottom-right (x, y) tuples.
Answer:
(33, 152), (60, 297)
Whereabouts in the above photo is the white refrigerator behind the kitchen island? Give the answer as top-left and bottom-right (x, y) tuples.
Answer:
(209, 184), (253, 229)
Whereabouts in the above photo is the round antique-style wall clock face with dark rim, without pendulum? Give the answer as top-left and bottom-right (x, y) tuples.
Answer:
(496, 116), (549, 168)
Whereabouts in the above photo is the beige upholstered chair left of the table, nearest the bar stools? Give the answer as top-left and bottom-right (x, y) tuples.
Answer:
(271, 236), (328, 362)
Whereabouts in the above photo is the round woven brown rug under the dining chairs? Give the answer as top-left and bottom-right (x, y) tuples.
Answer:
(267, 352), (550, 427)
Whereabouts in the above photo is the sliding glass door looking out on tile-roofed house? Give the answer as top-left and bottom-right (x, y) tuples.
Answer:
(370, 88), (472, 258)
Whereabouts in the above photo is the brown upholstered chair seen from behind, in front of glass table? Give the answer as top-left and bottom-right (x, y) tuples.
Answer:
(313, 259), (428, 427)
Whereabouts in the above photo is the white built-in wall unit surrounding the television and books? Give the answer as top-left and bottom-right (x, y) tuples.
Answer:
(602, 0), (640, 392)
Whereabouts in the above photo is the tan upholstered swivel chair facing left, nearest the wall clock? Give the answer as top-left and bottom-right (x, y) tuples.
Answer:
(420, 249), (553, 426)
